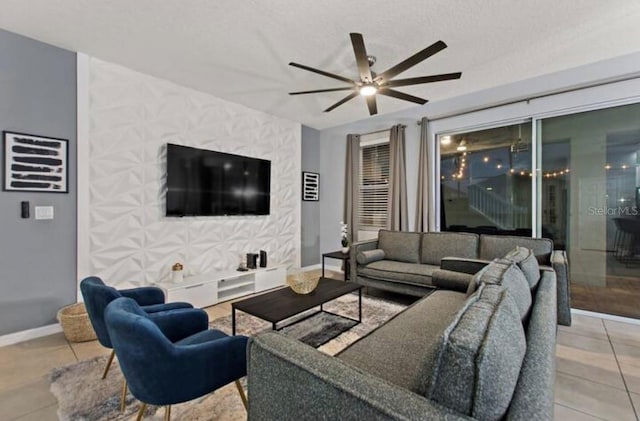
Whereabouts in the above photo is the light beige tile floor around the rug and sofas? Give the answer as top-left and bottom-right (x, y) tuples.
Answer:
(0, 302), (640, 421)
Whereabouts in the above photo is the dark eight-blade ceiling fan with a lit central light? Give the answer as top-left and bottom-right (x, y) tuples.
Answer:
(289, 33), (462, 115)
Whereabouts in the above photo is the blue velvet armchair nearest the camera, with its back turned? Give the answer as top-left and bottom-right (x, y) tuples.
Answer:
(105, 298), (248, 420)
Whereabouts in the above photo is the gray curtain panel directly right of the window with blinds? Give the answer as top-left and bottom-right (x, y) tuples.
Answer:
(387, 124), (409, 231)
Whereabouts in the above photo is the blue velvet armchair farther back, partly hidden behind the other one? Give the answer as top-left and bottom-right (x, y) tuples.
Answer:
(80, 276), (200, 410)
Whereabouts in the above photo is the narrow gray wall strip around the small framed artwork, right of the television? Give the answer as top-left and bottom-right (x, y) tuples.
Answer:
(300, 126), (320, 267)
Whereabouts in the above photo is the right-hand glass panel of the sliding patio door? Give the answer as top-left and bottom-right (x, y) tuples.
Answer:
(538, 104), (640, 318)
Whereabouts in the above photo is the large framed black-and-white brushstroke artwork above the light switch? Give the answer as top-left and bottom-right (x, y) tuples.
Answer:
(3, 132), (69, 193)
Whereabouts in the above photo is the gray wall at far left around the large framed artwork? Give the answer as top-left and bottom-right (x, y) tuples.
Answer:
(0, 30), (76, 335)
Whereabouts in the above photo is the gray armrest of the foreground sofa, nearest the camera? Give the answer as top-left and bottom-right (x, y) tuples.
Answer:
(247, 332), (471, 421)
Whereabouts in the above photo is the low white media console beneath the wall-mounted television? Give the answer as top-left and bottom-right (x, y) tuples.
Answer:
(155, 266), (287, 308)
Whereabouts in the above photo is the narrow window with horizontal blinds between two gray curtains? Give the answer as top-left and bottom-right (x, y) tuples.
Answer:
(359, 141), (389, 230)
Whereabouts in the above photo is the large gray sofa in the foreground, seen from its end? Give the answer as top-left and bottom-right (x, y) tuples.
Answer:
(248, 249), (557, 421)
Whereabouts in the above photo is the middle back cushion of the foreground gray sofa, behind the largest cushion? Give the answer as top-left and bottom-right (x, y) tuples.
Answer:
(477, 259), (532, 323)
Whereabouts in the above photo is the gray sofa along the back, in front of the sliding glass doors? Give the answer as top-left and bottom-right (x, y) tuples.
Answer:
(350, 230), (571, 326)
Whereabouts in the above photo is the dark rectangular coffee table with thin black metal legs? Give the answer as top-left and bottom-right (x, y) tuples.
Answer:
(231, 278), (362, 335)
